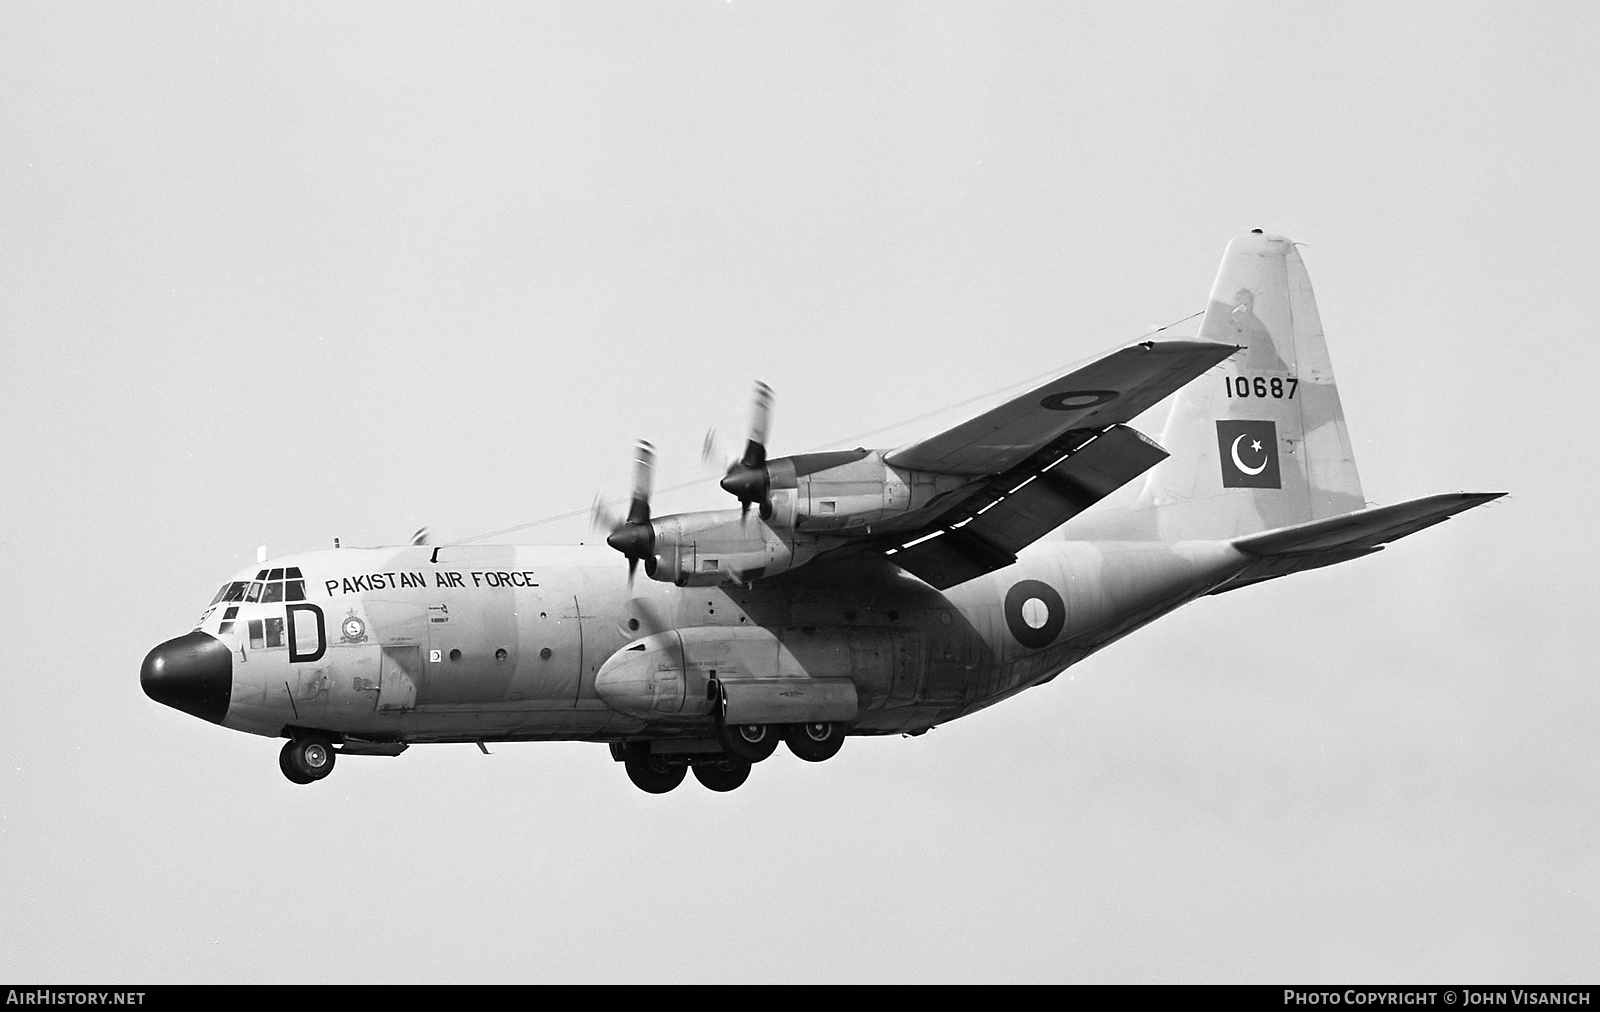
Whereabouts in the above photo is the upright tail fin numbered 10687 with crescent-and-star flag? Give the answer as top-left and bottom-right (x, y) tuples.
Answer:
(1139, 229), (1365, 540)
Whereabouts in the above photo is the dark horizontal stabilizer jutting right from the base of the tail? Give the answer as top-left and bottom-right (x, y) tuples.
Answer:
(1211, 492), (1506, 594)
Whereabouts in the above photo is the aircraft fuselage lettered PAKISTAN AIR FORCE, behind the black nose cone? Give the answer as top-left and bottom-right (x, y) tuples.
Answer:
(184, 540), (1245, 743)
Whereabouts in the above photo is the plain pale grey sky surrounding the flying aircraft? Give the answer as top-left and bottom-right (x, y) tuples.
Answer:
(0, 2), (1600, 982)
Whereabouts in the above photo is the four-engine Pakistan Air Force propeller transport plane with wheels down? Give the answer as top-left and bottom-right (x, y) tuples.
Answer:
(139, 231), (1502, 793)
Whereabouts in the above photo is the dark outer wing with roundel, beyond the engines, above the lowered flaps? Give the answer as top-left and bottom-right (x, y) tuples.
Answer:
(885, 341), (1238, 476)
